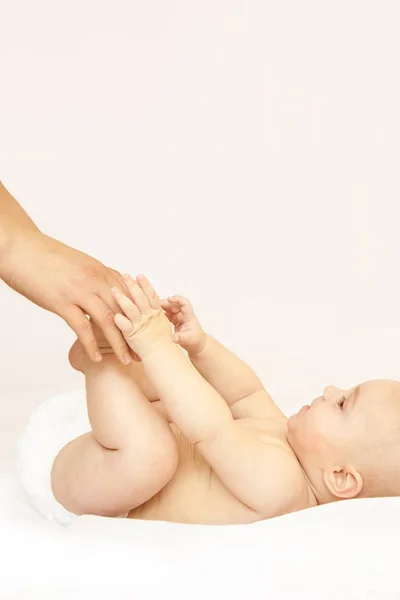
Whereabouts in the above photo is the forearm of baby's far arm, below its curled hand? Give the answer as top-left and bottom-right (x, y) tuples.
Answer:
(189, 336), (263, 406)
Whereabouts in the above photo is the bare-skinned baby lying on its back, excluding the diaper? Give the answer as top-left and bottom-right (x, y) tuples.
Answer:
(51, 275), (400, 524)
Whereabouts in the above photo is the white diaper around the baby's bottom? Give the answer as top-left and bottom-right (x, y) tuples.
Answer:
(17, 390), (91, 526)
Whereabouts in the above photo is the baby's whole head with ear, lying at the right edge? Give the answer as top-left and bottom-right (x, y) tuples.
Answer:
(288, 380), (400, 503)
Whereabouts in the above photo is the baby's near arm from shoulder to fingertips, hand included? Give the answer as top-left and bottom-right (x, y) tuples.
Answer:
(113, 277), (305, 517)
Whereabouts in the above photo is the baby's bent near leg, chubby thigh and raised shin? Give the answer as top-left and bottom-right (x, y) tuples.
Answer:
(52, 354), (178, 517)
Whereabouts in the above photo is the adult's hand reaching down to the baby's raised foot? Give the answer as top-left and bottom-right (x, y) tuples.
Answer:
(4, 232), (139, 364)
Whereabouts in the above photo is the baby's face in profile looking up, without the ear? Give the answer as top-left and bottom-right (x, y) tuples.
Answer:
(288, 380), (400, 467)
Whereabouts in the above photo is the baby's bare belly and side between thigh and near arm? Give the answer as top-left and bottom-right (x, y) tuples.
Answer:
(128, 424), (259, 525)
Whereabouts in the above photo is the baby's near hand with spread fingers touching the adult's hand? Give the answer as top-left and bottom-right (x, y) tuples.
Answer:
(111, 275), (173, 358)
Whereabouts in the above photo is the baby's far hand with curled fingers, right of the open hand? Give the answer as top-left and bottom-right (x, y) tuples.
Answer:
(161, 296), (207, 356)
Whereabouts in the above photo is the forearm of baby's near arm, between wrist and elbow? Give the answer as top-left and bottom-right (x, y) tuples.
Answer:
(141, 343), (232, 443)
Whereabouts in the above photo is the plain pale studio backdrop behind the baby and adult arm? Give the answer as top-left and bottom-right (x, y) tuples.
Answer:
(0, 0), (400, 467)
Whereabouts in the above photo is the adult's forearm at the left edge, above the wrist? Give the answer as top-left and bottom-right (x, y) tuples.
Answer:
(0, 182), (39, 278)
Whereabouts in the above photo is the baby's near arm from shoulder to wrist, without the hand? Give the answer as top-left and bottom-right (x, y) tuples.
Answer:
(136, 343), (305, 518)
